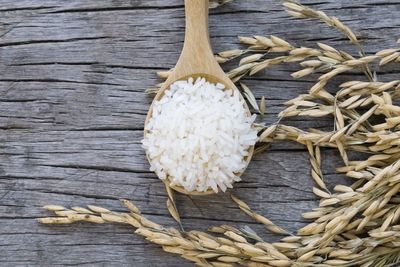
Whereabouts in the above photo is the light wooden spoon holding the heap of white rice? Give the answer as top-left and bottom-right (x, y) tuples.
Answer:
(145, 0), (254, 195)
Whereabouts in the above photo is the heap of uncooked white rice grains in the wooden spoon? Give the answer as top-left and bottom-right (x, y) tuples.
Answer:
(142, 78), (257, 192)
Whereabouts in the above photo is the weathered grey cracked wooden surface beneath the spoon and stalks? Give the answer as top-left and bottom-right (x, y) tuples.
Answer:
(0, 0), (400, 266)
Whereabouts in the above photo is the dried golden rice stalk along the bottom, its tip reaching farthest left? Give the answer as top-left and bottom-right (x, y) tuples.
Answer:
(38, 200), (290, 266)
